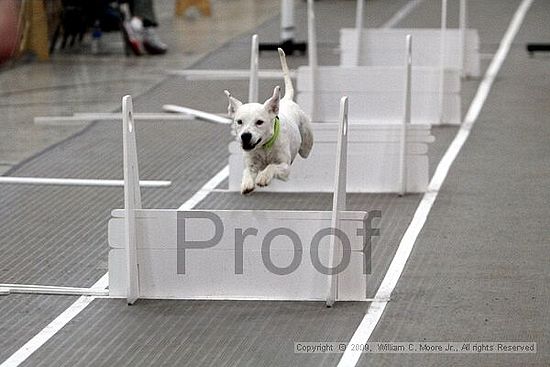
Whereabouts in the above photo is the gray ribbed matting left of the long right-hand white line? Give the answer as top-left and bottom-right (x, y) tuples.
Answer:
(0, 0), (496, 366)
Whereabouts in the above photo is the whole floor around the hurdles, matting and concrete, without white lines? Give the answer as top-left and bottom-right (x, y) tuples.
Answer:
(0, 0), (550, 367)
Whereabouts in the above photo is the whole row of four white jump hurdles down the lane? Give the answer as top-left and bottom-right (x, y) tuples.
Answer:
(6, 0), (479, 306)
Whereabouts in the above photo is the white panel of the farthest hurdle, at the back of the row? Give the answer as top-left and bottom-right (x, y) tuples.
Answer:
(340, 28), (481, 77)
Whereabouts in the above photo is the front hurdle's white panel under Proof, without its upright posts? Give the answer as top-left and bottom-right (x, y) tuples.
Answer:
(109, 210), (366, 301)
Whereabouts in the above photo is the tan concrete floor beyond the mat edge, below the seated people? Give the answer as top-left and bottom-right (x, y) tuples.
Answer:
(0, 0), (279, 173)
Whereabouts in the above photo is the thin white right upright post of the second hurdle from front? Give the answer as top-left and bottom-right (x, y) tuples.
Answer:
(399, 34), (412, 196)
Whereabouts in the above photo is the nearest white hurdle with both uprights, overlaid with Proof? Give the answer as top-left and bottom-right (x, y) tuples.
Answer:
(108, 96), (367, 305)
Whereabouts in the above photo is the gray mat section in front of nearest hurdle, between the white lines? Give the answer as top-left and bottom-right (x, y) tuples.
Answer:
(20, 300), (366, 366)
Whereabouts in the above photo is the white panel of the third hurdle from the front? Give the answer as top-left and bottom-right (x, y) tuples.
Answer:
(296, 67), (461, 125)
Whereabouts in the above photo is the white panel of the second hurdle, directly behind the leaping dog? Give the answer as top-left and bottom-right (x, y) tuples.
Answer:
(229, 123), (435, 193)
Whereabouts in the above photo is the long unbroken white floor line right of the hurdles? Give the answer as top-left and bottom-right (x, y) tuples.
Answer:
(338, 0), (533, 367)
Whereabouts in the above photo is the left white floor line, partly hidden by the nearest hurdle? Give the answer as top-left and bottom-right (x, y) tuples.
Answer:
(0, 166), (229, 367)
